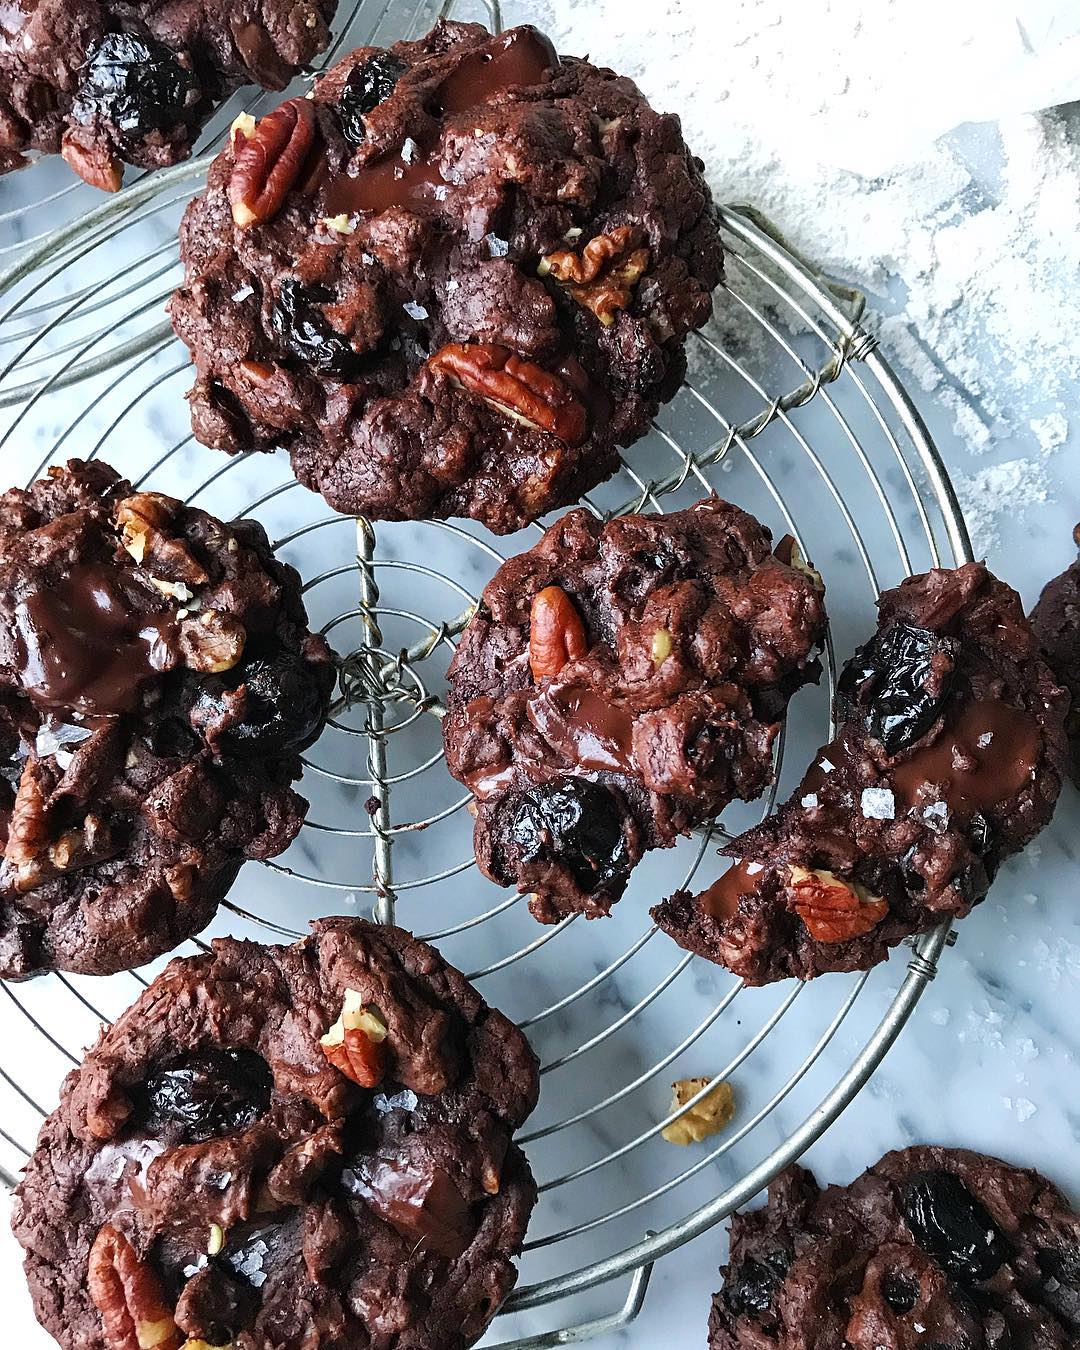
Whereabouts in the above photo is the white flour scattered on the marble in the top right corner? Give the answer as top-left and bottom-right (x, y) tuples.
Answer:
(532, 0), (1080, 552)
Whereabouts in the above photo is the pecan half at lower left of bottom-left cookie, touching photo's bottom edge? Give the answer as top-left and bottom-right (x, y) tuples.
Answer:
(86, 1223), (184, 1350)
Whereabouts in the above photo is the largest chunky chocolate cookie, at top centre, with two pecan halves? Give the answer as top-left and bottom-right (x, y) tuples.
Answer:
(170, 22), (721, 533)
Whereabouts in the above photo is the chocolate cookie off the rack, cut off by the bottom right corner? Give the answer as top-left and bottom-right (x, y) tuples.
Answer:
(709, 1148), (1080, 1350)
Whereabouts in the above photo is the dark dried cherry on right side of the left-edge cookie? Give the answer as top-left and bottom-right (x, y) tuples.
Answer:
(190, 652), (327, 756)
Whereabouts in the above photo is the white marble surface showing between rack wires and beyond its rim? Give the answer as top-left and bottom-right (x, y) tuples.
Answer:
(0, 2), (1080, 1350)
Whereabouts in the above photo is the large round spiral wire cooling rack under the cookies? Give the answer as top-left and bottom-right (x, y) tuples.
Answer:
(0, 3), (971, 1350)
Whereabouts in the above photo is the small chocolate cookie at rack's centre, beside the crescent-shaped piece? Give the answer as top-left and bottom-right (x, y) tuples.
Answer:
(443, 497), (825, 923)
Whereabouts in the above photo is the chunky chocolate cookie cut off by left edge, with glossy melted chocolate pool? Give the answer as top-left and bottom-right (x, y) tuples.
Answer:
(0, 459), (333, 979)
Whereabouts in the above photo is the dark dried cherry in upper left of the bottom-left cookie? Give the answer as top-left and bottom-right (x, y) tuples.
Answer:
(139, 1050), (273, 1143)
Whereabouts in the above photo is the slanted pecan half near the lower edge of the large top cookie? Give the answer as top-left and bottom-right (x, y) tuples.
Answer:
(428, 342), (589, 446)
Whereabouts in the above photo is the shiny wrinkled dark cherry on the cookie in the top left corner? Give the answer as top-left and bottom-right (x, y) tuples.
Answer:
(72, 32), (203, 135)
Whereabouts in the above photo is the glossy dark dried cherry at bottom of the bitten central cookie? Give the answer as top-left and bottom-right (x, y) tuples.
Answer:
(510, 778), (630, 892)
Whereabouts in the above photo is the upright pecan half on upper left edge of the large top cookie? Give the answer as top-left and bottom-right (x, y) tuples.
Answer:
(228, 99), (316, 230)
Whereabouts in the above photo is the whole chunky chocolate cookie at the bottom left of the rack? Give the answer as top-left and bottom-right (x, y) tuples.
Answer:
(14, 918), (539, 1350)
